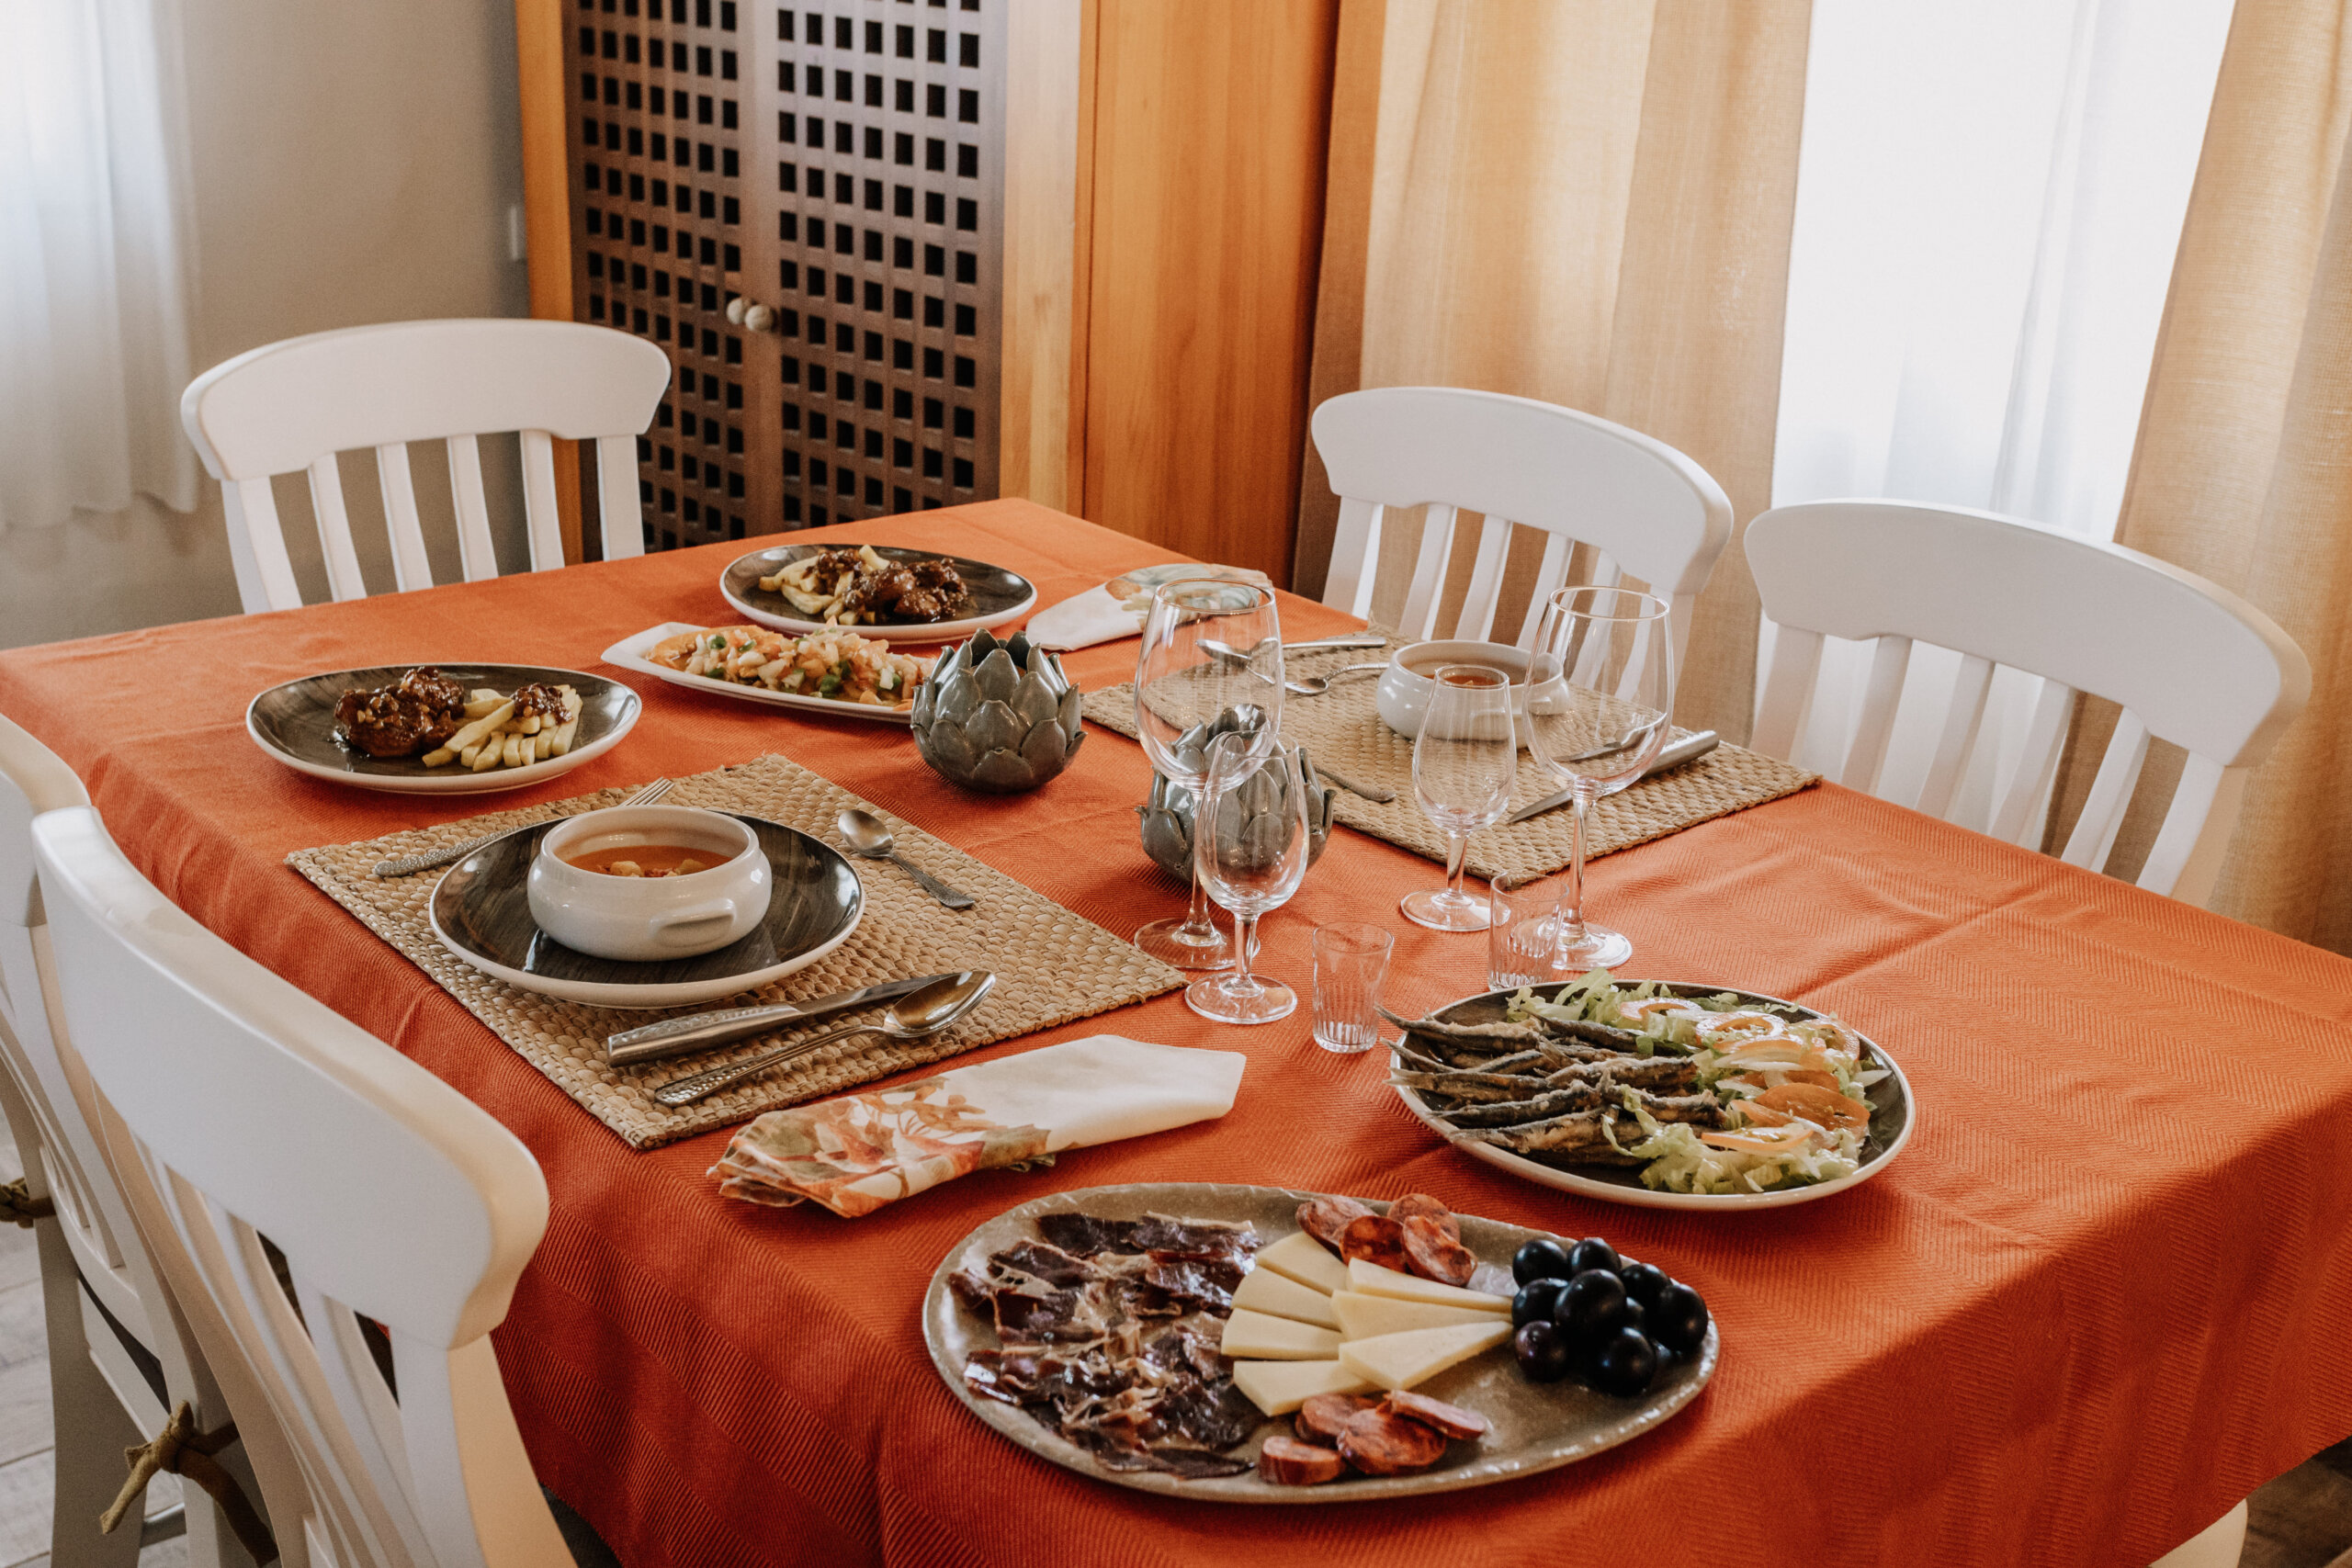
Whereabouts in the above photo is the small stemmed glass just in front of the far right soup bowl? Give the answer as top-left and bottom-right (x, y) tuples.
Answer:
(1397, 665), (1520, 931)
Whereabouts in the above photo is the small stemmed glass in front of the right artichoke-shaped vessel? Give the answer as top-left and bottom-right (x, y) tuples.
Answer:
(1183, 733), (1310, 1022)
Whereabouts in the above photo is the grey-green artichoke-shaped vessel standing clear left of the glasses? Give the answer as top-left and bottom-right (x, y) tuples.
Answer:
(912, 632), (1087, 795)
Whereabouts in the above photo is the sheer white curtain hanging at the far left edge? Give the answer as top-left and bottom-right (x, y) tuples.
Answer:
(0, 0), (195, 529)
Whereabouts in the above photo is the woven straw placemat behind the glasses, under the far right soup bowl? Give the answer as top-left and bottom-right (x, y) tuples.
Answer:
(1084, 637), (1820, 877)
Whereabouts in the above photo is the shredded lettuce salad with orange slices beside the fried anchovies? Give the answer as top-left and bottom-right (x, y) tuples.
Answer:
(1510, 968), (1886, 1194)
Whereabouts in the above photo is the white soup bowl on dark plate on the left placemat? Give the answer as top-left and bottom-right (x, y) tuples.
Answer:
(526, 807), (774, 962)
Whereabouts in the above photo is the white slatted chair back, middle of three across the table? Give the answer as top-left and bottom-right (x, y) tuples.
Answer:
(1312, 386), (1731, 668)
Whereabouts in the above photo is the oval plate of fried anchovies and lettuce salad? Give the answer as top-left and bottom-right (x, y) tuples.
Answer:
(1387, 971), (1919, 1208)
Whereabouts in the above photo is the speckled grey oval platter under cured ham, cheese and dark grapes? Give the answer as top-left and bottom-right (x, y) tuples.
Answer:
(922, 1182), (1719, 1505)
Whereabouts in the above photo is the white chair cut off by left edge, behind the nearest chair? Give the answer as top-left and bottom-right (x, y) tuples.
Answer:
(0, 717), (303, 1568)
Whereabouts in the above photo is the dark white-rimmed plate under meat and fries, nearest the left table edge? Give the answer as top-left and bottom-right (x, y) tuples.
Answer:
(244, 660), (644, 795)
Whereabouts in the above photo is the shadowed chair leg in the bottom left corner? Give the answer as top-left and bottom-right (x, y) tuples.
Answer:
(35, 1220), (151, 1568)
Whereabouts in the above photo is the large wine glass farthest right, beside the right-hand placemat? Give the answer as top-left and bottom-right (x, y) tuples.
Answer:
(1526, 588), (1675, 974)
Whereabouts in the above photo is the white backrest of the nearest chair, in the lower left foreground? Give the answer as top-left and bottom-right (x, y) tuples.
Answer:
(33, 807), (571, 1568)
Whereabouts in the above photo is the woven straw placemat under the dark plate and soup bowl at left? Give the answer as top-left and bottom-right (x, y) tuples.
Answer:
(287, 757), (1183, 1149)
